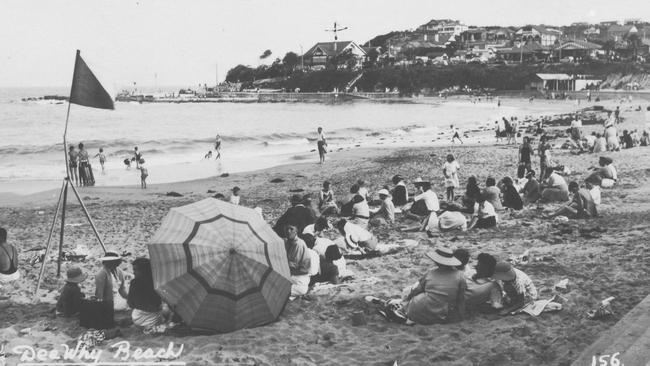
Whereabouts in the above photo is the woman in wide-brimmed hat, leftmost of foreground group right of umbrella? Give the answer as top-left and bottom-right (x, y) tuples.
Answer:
(403, 246), (467, 325)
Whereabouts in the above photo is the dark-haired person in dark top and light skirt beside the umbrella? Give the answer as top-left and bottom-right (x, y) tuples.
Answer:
(126, 258), (165, 330)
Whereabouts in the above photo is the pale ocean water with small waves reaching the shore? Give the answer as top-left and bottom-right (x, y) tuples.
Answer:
(0, 88), (568, 193)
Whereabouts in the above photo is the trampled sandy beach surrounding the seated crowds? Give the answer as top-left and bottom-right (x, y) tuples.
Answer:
(0, 98), (650, 365)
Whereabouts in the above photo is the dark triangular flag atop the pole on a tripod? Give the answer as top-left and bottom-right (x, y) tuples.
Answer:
(70, 50), (115, 109)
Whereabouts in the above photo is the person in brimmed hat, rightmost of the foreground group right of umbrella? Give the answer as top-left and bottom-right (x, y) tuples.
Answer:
(493, 262), (537, 315)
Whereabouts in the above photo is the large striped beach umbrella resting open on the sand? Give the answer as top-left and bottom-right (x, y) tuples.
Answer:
(148, 198), (291, 332)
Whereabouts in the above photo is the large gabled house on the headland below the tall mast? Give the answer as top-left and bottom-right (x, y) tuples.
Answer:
(303, 41), (366, 69)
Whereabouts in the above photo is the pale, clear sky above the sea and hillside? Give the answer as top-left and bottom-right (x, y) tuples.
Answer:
(0, 0), (650, 90)
